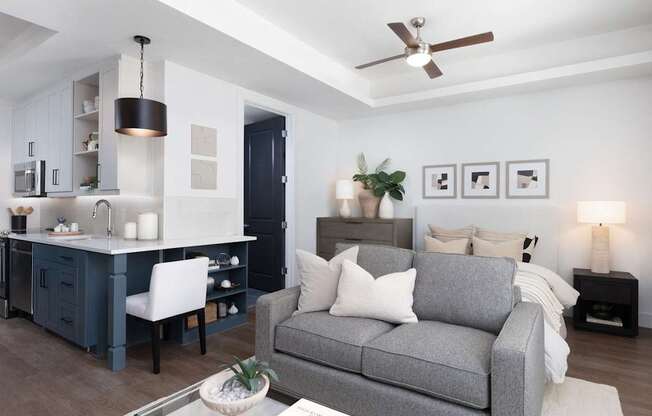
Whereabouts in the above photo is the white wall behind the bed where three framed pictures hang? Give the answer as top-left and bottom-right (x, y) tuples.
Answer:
(336, 78), (652, 326)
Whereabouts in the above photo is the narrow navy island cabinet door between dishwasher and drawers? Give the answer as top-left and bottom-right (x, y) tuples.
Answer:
(33, 260), (59, 330)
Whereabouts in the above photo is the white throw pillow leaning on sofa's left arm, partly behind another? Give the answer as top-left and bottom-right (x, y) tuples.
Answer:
(294, 246), (359, 314)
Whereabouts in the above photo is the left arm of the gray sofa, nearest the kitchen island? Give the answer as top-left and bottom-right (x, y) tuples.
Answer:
(256, 286), (301, 362)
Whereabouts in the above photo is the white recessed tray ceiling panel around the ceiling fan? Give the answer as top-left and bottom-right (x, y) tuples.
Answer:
(237, 0), (652, 97)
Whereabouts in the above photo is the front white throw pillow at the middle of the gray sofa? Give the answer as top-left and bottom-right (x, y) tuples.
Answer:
(330, 260), (417, 324)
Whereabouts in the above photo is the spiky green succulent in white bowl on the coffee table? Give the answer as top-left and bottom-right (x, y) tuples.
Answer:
(199, 357), (278, 416)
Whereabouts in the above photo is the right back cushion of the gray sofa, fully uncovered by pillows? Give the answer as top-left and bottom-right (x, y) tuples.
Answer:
(413, 253), (516, 334)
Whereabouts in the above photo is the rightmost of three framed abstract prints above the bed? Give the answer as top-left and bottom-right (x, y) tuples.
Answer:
(505, 159), (550, 198)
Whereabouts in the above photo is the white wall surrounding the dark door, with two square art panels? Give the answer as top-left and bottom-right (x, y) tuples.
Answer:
(163, 62), (338, 285)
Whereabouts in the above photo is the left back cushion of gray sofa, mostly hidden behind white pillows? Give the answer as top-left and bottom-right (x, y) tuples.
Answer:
(335, 243), (414, 277)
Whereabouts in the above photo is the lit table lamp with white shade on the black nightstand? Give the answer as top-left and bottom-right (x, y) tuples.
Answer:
(577, 201), (626, 274)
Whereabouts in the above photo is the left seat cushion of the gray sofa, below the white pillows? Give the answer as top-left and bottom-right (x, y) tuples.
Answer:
(274, 312), (394, 373)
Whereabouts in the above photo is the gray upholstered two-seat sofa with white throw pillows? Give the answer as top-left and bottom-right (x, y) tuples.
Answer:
(256, 245), (544, 416)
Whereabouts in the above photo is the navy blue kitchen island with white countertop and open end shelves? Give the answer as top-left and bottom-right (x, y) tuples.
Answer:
(10, 234), (255, 371)
